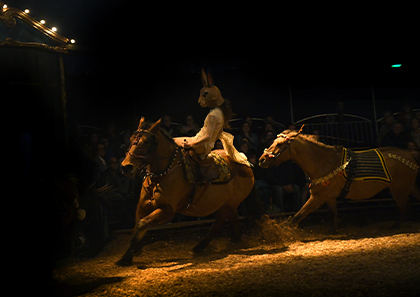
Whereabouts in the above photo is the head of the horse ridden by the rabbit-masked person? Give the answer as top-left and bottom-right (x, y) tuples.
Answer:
(121, 117), (161, 177)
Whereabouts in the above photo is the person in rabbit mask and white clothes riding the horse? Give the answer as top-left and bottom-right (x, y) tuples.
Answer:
(174, 69), (249, 166)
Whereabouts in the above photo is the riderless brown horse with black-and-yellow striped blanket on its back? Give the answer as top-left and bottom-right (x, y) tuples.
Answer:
(259, 130), (420, 228)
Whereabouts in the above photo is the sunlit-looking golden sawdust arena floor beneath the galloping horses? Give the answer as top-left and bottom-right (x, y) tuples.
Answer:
(52, 220), (420, 297)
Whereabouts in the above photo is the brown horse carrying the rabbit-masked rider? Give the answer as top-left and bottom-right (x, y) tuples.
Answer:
(117, 118), (254, 266)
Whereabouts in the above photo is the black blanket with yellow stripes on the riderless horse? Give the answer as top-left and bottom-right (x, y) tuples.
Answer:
(341, 148), (391, 183)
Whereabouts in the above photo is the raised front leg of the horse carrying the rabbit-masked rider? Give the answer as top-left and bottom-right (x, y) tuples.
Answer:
(116, 206), (175, 266)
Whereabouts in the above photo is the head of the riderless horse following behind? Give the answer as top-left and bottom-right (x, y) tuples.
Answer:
(259, 126), (303, 168)
